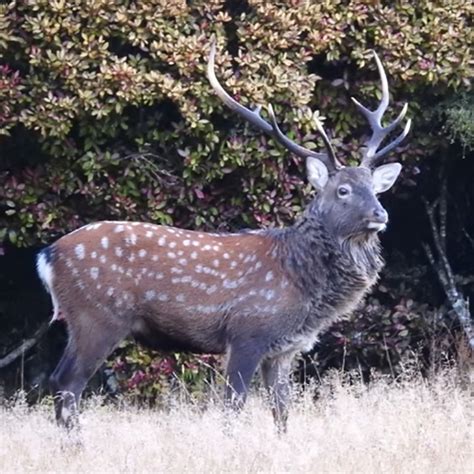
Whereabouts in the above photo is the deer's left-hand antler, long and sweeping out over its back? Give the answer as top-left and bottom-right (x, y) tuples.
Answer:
(207, 38), (341, 170)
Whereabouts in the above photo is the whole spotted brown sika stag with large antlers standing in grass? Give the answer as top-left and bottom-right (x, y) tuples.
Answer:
(37, 44), (410, 430)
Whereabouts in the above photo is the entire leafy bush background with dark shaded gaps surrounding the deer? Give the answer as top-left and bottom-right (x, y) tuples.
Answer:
(0, 0), (474, 400)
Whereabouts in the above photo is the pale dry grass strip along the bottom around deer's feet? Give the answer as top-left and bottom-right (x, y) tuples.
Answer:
(0, 374), (473, 474)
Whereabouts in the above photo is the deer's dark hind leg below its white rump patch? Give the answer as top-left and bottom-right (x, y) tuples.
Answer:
(49, 318), (128, 430)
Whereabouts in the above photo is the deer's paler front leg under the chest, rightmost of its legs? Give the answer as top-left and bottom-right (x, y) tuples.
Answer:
(261, 353), (295, 433)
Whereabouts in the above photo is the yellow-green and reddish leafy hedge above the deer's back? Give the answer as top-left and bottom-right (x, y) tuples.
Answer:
(0, 0), (473, 246)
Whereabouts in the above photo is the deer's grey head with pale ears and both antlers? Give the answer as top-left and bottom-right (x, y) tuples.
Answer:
(208, 42), (411, 240)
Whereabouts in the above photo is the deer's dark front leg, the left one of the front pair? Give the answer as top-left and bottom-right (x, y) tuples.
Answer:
(225, 344), (262, 410)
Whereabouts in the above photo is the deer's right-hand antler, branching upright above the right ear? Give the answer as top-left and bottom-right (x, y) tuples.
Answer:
(352, 51), (411, 167)
